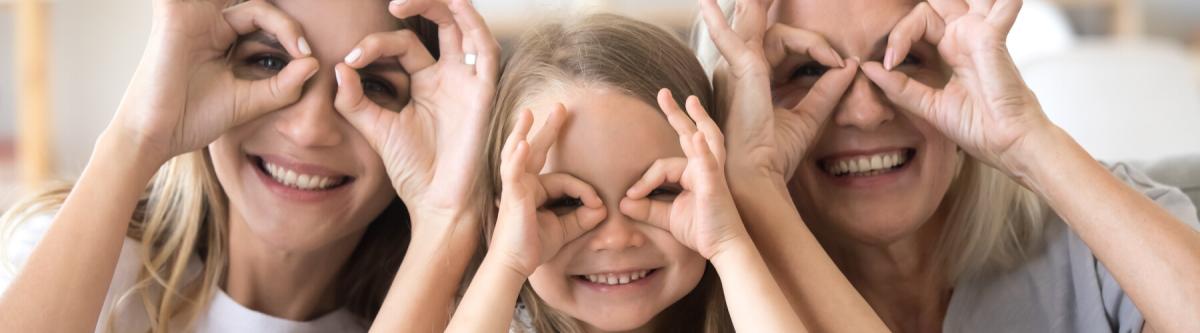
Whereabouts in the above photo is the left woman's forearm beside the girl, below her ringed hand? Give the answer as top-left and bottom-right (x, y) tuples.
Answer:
(371, 212), (479, 332)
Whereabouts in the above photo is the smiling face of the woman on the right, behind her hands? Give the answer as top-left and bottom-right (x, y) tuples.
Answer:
(773, 0), (959, 244)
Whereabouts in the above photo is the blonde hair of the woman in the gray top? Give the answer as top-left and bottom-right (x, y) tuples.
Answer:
(691, 0), (1046, 281)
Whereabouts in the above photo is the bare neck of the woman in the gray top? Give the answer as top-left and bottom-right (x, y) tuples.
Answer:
(823, 213), (953, 332)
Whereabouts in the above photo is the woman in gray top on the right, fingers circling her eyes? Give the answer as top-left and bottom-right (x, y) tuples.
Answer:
(702, 0), (1200, 332)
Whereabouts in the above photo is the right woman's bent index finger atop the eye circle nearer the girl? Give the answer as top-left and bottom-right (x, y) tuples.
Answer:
(763, 24), (846, 80)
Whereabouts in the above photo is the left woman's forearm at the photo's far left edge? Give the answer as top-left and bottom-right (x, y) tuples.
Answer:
(0, 131), (158, 332)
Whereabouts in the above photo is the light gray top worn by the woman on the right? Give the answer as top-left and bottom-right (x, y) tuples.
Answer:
(942, 164), (1200, 333)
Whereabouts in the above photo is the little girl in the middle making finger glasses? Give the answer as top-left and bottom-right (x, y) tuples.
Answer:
(448, 14), (805, 332)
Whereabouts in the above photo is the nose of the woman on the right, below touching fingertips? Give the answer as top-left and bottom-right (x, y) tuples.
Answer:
(834, 72), (895, 132)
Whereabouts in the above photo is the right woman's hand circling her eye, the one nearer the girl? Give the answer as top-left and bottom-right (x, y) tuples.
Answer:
(701, 0), (854, 180)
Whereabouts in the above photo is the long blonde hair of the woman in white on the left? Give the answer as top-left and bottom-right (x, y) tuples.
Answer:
(0, 17), (438, 332)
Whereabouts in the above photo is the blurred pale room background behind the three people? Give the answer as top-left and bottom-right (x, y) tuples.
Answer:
(0, 0), (1200, 211)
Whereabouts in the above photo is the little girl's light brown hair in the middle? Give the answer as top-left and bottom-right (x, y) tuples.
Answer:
(484, 14), (732, 332)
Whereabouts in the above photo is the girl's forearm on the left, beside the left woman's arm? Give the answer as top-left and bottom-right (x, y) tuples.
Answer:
(446, 253), (527, 332)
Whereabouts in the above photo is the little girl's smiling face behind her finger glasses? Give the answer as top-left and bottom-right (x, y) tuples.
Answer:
(529, 87), (706, 332)
